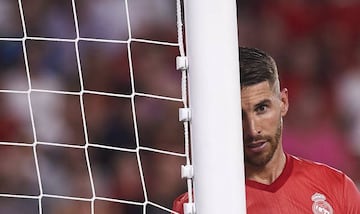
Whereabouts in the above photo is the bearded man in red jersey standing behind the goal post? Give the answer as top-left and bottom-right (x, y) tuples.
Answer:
(173, 47), (360, 214)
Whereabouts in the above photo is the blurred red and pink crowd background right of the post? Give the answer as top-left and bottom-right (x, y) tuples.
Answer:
(238, 0), (360, 185)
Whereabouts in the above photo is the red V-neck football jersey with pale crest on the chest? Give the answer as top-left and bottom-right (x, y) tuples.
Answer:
(173, 155), (360, 214)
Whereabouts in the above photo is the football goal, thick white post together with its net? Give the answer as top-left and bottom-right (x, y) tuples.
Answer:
(0, 0), (245, 214)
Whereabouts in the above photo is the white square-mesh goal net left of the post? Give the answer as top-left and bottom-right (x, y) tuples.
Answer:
(0, 0), (189, 214)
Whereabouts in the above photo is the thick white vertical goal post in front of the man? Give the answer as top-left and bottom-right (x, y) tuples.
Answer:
(184, 0), (246, 214)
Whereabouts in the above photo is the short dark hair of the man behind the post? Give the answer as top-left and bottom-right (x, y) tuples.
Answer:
(239, 47), (280, 90)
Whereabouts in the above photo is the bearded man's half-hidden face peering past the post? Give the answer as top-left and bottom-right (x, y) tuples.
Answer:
(241, 81), (288, 168)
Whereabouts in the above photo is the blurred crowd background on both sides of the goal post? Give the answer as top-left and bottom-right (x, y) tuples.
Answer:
(0, 0), (360, 214)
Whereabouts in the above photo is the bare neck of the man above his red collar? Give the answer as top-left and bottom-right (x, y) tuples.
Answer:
(245, 148), (286, 185)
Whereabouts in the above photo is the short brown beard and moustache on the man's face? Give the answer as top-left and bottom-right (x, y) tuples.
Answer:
(244, 121), (282, 168)
